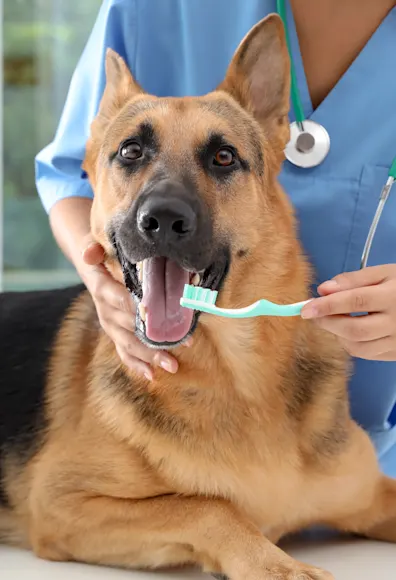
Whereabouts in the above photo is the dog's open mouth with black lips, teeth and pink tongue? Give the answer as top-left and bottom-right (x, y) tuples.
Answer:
(114, 242), (228, 347)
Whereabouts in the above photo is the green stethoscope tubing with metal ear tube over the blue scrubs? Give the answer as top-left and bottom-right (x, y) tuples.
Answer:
(276, 0), (396, 268)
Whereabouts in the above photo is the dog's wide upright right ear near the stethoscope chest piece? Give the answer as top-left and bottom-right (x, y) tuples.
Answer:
(218, 14), (290, 152)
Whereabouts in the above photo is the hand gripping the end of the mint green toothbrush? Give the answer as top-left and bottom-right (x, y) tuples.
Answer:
(301, 264), (396, 361)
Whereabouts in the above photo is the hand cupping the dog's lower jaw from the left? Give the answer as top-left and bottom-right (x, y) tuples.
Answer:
(82, 238), (178, 380)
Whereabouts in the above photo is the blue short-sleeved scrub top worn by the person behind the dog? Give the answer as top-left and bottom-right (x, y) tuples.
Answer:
(36, 0), (396, 476)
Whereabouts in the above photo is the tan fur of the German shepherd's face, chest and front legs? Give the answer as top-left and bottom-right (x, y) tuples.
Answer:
(0, 17), (396, 580)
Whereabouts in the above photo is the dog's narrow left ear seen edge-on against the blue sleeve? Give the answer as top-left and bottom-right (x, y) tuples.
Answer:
(82, 48), (144, 182)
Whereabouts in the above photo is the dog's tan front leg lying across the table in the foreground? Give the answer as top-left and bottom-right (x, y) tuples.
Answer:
(31, 494), (332, 580)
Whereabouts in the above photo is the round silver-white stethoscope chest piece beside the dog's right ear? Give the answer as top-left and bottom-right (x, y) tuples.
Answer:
(285, 119), (330, 167)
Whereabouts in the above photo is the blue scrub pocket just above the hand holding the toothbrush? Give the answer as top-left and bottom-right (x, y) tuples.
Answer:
(280, 163), (396, 283)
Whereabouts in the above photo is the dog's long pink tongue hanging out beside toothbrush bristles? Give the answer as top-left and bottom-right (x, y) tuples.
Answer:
(142, 258), (194, 342)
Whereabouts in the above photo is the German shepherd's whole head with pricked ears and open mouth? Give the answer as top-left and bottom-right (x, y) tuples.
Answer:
(84, 15), (290, 347)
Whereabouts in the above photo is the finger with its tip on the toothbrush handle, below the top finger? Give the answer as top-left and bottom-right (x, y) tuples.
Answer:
(301, 286), (391, 318)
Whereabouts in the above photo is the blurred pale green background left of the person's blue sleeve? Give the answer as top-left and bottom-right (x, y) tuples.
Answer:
(0, 0), (101, 290)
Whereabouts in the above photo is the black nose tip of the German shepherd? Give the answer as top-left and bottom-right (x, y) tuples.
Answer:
(137, 194), (197, 243)
